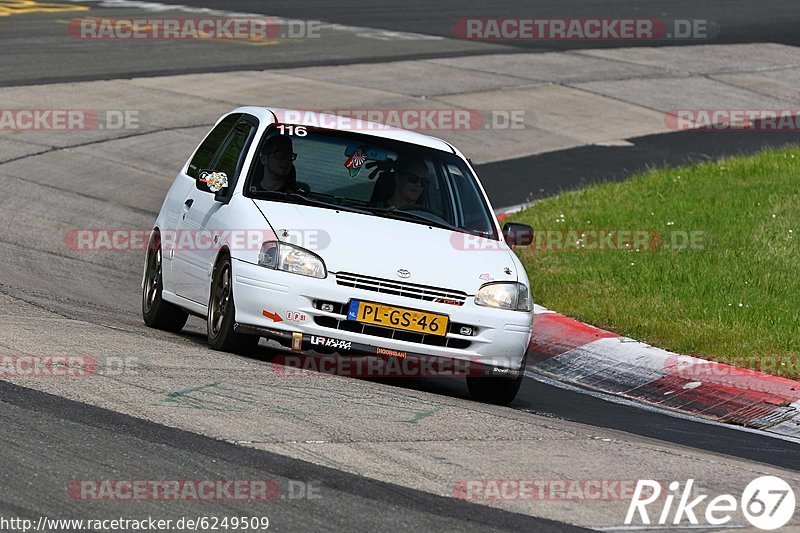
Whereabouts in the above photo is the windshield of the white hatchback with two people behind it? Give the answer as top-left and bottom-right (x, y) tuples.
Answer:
(245, 125), (498, 240)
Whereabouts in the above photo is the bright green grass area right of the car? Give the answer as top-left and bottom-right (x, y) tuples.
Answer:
(510, 148), (800, 377)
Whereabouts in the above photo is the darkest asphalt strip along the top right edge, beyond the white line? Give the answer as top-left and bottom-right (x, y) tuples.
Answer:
(147, 0), (800, 50)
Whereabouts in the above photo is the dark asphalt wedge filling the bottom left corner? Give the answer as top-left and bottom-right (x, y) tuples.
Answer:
(0, 381), (582, 533)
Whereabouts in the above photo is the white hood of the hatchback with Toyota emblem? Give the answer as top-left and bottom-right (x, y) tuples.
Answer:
(254, 200), (527, 295)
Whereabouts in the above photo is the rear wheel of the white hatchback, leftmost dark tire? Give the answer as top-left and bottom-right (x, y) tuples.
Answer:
(142, 233), (189, 333)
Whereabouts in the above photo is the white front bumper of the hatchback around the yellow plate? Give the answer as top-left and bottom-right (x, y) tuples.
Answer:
(233, 260), (533, 370)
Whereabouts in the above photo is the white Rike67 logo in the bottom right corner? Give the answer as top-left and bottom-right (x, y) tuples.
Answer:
(625, 476), (795, 530)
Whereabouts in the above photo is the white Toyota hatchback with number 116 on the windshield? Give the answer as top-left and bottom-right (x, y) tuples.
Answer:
(142, 107), (533, 403)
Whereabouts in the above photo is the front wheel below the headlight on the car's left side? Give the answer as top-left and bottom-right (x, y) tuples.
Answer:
(206, 256), (259, 353)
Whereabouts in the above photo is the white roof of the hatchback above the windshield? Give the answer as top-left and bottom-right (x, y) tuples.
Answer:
(232, 106), (458, 153)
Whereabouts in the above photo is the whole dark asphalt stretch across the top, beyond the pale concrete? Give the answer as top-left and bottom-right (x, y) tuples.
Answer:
(0, 0), (800, 86)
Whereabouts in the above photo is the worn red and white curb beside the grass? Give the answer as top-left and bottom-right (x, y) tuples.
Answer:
(528, 306), (800, 437)
